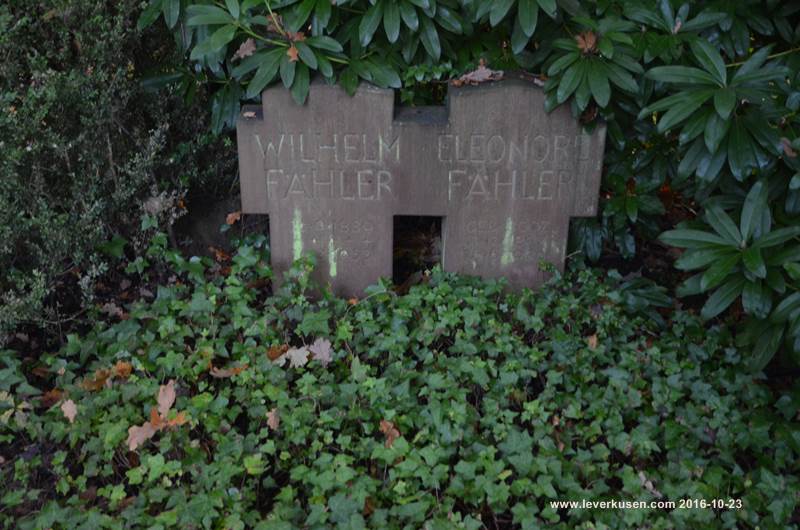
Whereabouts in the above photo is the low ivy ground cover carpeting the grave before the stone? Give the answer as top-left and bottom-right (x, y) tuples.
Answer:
(0, 245), (800, 530)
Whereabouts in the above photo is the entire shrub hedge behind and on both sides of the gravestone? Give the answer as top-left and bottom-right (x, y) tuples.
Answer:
(0, 0), (800, 369)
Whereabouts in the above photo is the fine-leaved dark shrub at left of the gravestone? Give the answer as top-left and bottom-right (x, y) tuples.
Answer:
(0, 0), (235, 342)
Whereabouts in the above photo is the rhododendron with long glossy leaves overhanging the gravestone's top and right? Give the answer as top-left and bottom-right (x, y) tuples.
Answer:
(134, 0), (800, 368)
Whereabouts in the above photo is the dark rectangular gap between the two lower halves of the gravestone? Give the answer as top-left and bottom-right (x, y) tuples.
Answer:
(392, 215), (442, 285)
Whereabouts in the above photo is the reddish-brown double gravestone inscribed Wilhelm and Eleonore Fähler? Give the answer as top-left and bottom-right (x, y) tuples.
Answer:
(237, 79), (605, 296)
